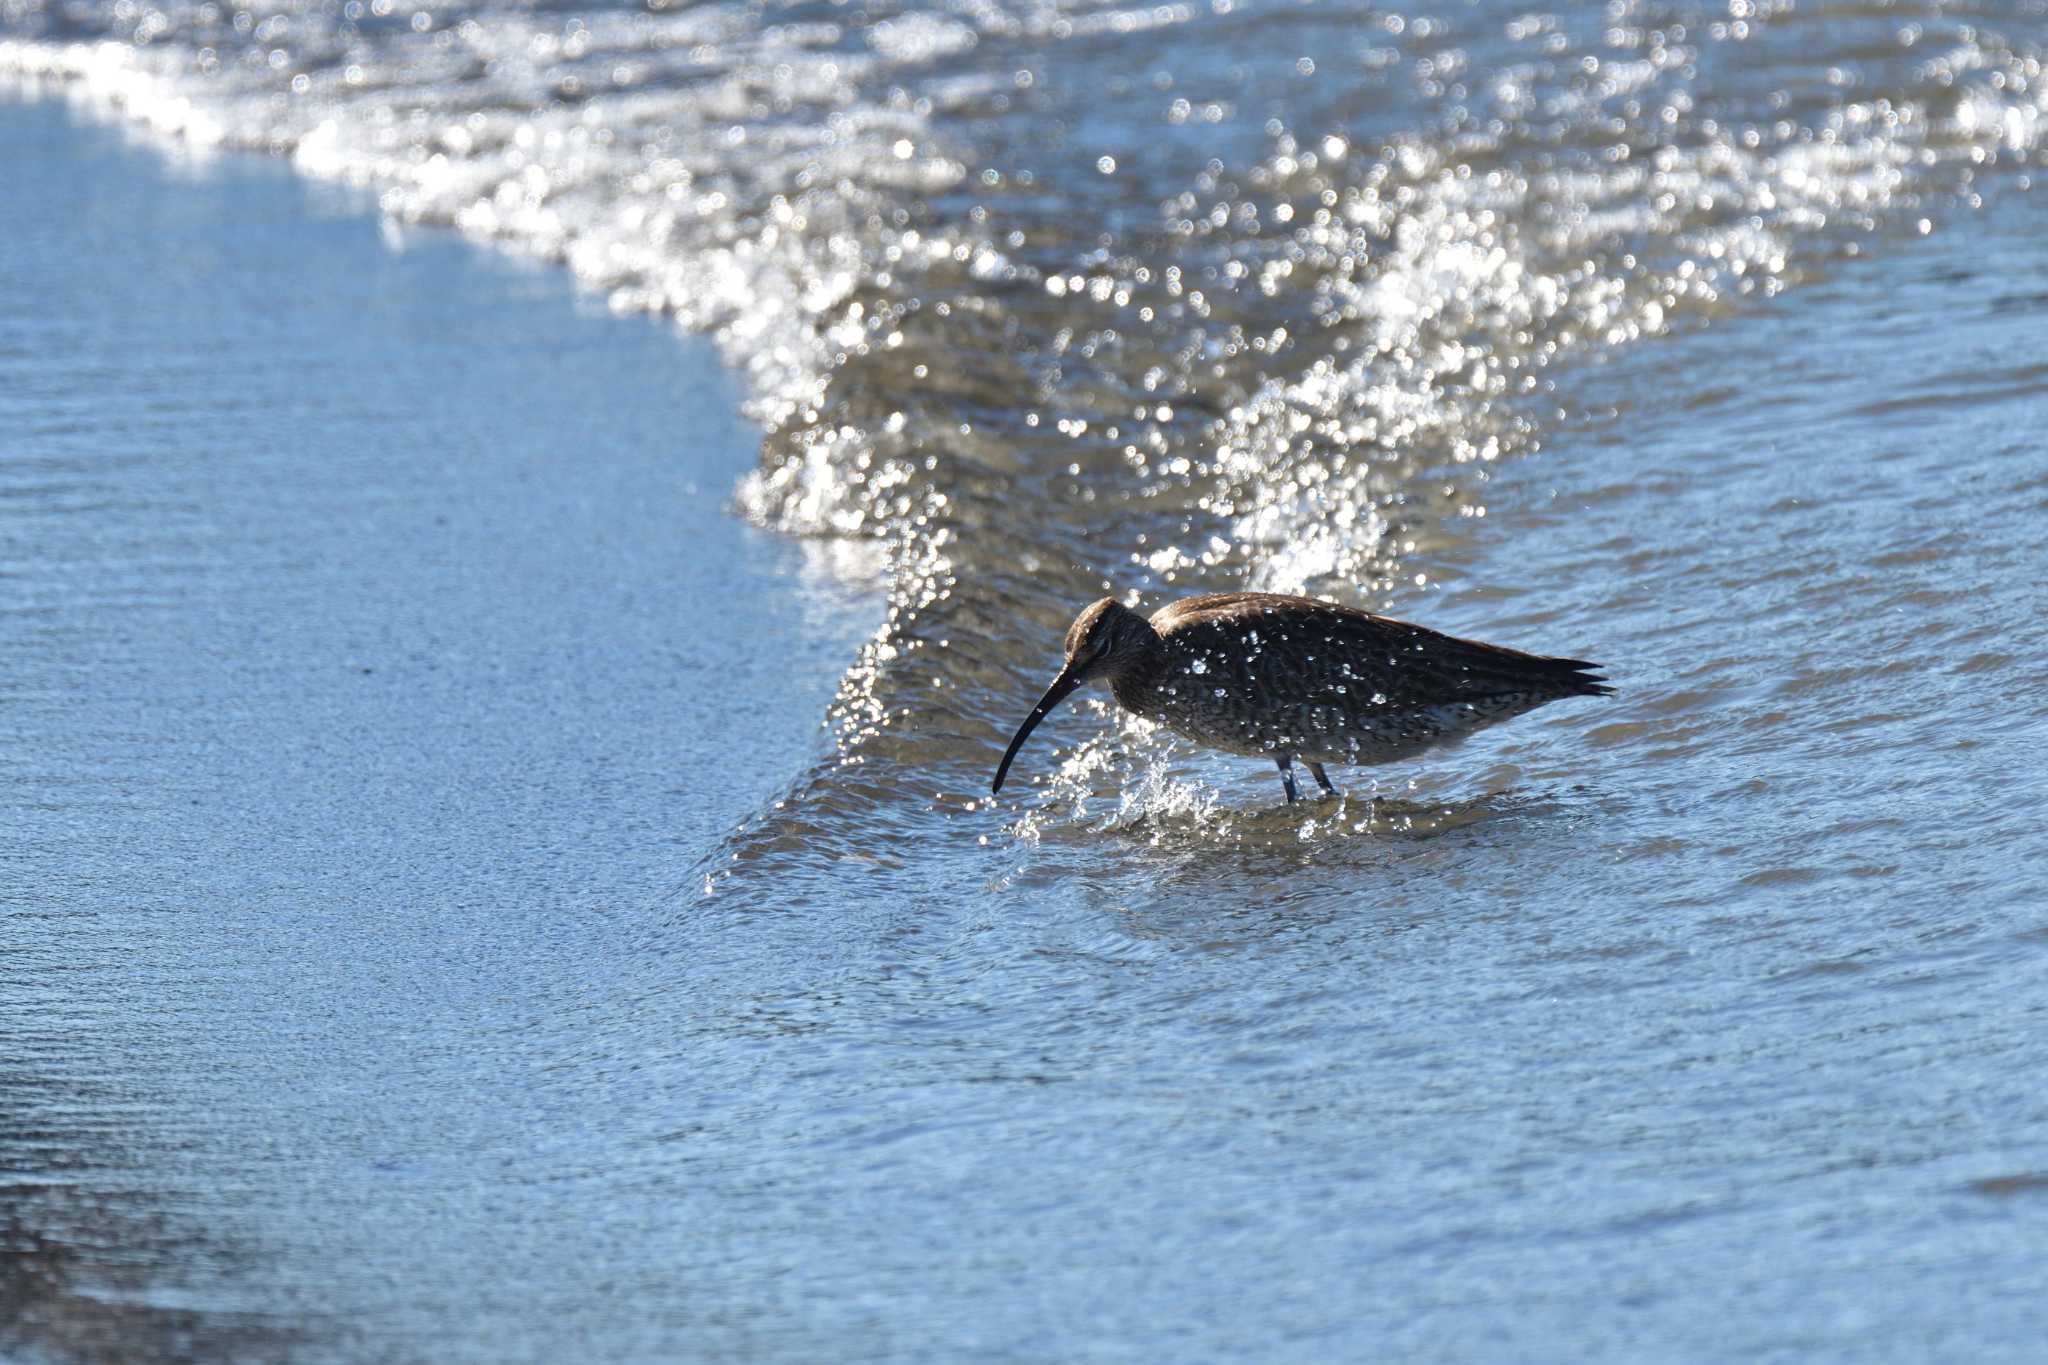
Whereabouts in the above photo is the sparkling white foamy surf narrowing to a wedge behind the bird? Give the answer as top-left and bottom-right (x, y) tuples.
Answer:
(0, 0), (2044, 777)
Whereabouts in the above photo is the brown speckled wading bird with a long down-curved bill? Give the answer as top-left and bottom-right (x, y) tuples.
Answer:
(991, 591), (1614, 800)
